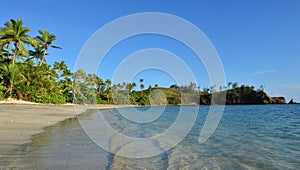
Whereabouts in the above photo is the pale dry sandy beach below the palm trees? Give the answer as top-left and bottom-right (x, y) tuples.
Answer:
(0, 101), (123, 164)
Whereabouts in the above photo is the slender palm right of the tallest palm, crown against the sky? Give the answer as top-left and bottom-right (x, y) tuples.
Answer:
(34, 30), (62, 66)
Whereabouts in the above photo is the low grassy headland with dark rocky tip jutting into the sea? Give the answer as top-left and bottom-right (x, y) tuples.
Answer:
(160, 86), (293, 105)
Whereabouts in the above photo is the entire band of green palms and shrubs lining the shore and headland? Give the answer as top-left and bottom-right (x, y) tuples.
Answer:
(0, 19), (285, 105)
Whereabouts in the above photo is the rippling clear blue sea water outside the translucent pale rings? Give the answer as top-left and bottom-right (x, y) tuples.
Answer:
(7, 105), (300, 170)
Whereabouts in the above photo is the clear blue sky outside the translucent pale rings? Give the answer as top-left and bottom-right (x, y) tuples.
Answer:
(0, 0), (300, 102)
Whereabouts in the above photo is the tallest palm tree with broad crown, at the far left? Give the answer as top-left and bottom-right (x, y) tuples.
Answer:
(0, 19), (33, 64)
